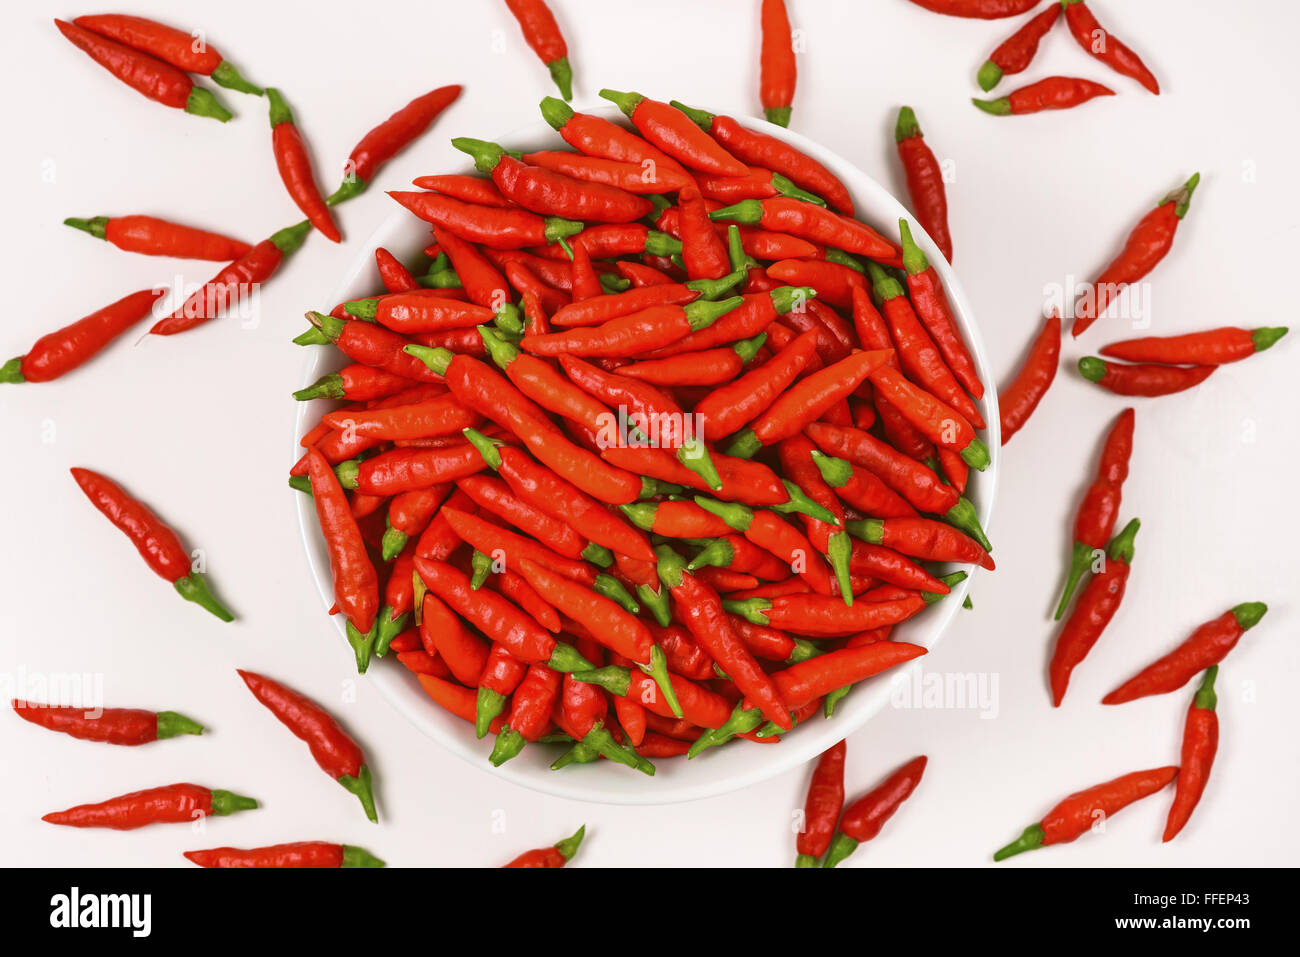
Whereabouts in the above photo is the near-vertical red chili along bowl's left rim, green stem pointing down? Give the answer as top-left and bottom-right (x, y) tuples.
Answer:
(307, 449), (380, 650)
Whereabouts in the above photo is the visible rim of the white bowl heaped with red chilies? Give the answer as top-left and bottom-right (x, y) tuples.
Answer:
(294, 107), (1001, 805)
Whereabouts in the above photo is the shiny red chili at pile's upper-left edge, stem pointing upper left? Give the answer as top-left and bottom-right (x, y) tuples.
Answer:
(451, 137), (654, 222)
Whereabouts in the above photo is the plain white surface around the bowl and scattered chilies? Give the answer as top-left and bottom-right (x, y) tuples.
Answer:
(0, 0), (1300, 866)
